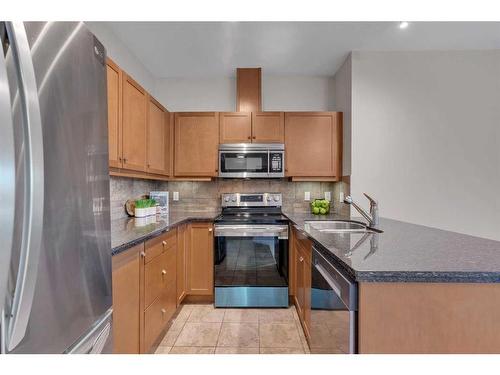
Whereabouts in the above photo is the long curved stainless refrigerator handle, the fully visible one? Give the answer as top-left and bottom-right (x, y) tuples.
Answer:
(5, 22), (44, 351)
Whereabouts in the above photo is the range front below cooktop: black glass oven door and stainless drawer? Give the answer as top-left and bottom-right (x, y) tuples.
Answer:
(214, 224), (288, 307)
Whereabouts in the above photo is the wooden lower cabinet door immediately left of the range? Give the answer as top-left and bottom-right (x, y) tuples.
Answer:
(186, 222), (214, 296)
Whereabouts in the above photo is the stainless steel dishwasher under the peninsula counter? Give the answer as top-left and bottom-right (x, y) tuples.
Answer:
(310, 247), (358, 354)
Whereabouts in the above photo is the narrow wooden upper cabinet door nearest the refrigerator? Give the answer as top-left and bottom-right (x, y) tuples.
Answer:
(106, 59), (122, 168)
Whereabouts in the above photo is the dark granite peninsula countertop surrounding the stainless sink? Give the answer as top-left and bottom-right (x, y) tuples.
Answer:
(285, 213), (500, 283)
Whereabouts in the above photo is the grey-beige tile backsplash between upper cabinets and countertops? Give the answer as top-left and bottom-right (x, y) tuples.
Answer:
(110, 177), (349, 219)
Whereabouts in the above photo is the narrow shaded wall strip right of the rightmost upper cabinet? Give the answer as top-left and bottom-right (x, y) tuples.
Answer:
(334, 54), (352, 176)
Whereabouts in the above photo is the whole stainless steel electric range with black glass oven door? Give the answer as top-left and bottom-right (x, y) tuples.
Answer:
(214, 193), (288, 307)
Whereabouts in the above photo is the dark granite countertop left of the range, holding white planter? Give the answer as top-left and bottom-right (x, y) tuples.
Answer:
(111, 211), (220, 255)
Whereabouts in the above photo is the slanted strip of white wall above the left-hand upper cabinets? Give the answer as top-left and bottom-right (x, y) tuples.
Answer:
(85, 22), (156, 94)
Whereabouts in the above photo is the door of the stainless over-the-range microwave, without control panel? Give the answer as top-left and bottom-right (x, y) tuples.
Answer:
(219, 150), (269, 178)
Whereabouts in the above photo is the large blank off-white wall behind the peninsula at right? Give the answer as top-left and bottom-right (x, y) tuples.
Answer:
(351, 50), (500, 240)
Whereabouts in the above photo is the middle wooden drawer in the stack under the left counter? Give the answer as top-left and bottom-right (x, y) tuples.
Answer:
(144, 247), (176, 307)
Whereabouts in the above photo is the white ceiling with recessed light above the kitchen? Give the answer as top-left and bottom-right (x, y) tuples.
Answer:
(106, 22), (500, 78)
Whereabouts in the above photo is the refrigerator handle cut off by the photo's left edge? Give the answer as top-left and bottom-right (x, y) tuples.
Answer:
(0, 24), (16, 315)
